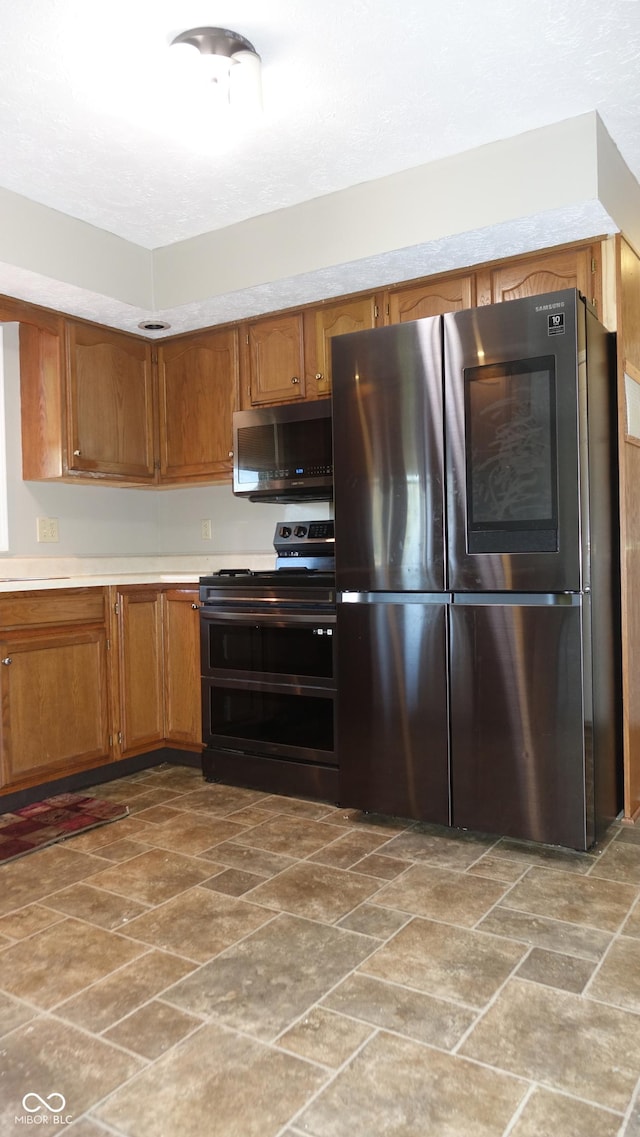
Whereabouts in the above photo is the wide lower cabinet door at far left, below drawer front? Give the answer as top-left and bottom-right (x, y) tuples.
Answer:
(0, 628), (110, 789)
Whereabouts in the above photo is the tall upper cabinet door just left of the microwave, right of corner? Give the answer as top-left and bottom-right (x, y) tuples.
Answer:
(158, 329), (239, 481)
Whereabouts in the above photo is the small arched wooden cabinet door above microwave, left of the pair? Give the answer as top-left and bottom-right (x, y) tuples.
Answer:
(242, 313), (306, 406)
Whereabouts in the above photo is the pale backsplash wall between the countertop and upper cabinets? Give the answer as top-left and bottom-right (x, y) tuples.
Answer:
(0, 324), (332, 558)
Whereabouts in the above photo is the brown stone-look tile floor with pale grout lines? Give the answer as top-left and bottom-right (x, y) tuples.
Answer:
(0, 765), (640, 1137)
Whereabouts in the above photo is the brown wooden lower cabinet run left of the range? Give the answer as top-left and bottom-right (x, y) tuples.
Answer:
(0, 584), (201, 795)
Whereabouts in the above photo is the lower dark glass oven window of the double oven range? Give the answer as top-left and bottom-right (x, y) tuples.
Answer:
(209, 686), (333, 757)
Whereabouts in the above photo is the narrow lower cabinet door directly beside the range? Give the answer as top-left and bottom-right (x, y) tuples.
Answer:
(163, 588), (202, 750)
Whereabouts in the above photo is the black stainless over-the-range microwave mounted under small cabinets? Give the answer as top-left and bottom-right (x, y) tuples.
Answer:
(233, 399), (333, 503)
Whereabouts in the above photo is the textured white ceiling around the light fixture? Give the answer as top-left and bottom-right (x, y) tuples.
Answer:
(0, 0), (640, 323)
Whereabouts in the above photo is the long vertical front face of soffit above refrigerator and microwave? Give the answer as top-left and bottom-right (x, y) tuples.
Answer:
(153, 111), (604, 310)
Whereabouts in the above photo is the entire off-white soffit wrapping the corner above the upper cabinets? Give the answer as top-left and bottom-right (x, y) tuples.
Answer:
(0, 111), (640, 338)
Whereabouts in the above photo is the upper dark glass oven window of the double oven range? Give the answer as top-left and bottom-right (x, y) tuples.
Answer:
(205, 621), (333, 679)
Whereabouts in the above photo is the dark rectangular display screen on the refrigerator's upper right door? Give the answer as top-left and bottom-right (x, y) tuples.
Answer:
(465, 356), (558, 553)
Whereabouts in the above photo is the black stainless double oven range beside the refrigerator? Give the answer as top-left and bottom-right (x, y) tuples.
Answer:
(200, 521), (338, 800)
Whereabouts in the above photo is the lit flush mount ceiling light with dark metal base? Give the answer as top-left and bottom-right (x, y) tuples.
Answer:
(171, 27), (261, 111)
